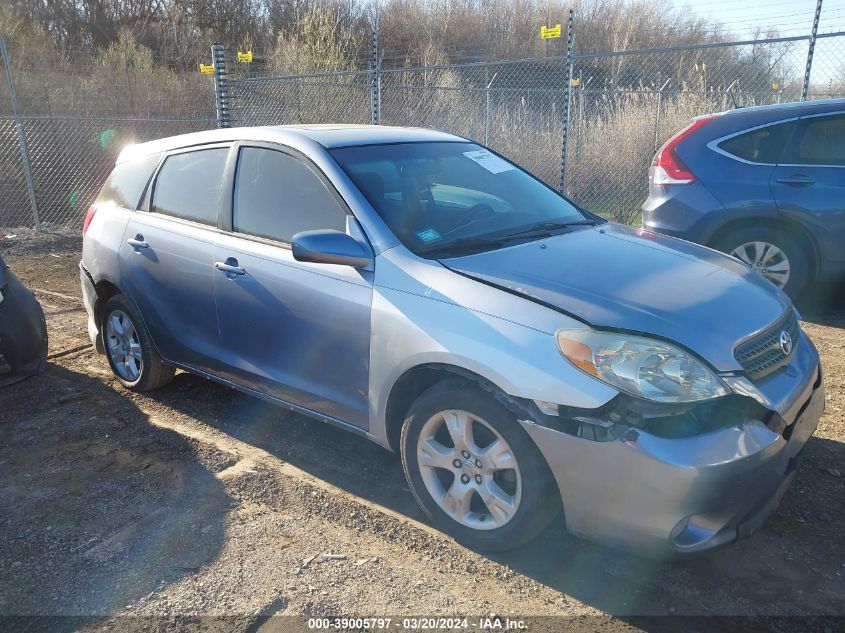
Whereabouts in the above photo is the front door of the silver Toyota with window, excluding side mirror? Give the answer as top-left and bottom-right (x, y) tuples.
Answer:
(214, 144), (372, 428)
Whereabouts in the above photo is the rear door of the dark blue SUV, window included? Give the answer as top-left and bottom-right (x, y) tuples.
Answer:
(770, 112), (845, 261)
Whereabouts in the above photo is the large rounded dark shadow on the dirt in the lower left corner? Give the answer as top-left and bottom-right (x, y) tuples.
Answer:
(0, 363), (233, 630)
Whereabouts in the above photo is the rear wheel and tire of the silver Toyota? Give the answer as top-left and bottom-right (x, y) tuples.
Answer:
(100, 294), (176, 391)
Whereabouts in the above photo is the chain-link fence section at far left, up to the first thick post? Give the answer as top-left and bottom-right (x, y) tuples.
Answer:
(0, 37), (217, 233)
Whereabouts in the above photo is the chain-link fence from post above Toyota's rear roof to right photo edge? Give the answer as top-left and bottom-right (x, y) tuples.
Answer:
(228, 26), (845, 223)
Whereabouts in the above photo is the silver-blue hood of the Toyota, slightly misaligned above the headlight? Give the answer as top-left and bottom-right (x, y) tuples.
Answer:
(441, 223), (791, 371)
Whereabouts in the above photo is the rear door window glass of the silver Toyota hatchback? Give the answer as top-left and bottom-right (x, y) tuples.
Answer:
(151, 147), (229, 225)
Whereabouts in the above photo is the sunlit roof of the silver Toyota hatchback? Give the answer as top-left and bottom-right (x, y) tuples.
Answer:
(117, 124), (467, 163)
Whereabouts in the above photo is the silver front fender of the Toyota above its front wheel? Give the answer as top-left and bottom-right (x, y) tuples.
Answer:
(370, 253), (618, 446)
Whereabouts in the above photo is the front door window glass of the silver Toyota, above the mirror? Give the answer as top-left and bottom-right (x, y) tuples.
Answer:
(232, 147), (346, 242)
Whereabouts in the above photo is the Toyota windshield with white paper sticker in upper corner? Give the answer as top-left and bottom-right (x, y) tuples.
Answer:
(331, 142), (598, 257)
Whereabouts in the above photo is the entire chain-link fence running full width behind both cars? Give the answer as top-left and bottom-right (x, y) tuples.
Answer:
(0, 19), (845, 230)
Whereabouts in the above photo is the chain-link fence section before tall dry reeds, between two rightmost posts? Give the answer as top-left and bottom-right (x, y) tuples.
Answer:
(564, 38), (824, 223)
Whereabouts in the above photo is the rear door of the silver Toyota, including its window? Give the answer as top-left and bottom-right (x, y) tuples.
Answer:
(120, 145), (230, 371)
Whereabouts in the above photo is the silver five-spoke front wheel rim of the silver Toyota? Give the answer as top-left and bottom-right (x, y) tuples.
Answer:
(417, 409), (522, 530)
